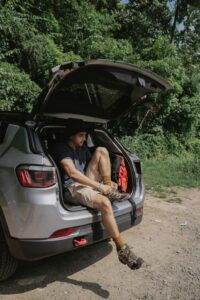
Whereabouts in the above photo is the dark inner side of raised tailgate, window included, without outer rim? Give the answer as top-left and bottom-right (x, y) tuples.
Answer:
(41, 65), (161, 120)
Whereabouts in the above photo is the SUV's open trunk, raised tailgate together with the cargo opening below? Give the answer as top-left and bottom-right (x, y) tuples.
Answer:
(31, 59), (170, 210)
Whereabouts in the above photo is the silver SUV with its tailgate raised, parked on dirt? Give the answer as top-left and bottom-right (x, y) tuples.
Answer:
(0, 60), (169, 280)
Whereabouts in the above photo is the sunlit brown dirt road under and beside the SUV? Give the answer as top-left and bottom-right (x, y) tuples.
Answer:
(0, 188), (200, 300)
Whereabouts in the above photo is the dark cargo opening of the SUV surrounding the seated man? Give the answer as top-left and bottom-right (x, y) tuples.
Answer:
(39, 124), (136, 211)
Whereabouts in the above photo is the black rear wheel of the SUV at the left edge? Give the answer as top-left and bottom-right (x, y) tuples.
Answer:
(0, 225), (18, 281)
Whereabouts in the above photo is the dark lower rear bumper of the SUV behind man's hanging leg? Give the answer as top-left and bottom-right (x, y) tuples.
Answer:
(7, 213), (142, 261)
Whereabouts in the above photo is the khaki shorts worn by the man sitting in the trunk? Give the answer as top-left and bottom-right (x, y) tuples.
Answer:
(65, 182), (100, 208)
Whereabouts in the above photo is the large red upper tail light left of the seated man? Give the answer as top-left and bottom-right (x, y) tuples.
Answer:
(16, 166), (56, 188)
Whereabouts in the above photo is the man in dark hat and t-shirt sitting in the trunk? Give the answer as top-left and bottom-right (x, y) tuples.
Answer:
(51, 120), (143, 269)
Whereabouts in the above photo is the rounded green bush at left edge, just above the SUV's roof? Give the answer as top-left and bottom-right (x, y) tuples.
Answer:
(0, 63), (40, 112)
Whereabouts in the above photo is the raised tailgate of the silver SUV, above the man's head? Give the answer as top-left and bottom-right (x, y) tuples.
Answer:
(31, 59), (170, 123)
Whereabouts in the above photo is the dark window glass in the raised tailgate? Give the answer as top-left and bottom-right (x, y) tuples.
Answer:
(45, 83), (132, 118)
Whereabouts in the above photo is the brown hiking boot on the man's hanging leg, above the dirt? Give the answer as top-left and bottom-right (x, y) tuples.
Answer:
(118, 244), (144, 270)
